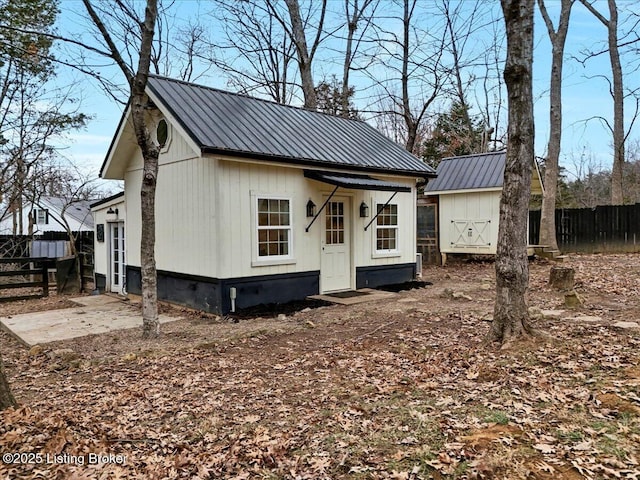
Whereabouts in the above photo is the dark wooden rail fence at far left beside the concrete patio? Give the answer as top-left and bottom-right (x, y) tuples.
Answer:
(0, 257), (50, 302)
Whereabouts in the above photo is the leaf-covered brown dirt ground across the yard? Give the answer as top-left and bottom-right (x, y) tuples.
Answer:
(0, 255), (640, 480)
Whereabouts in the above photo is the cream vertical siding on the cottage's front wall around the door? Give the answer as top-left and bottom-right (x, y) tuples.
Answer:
(217, 160), (415, 288)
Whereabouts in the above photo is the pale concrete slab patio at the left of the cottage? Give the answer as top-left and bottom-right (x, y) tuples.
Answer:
(0, 295), (178, 347)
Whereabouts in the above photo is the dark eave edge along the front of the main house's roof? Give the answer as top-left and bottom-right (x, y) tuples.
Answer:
(202, 147), (436, 178)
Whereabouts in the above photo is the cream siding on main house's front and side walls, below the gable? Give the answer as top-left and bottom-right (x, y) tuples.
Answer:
(126, 152), (416, 288)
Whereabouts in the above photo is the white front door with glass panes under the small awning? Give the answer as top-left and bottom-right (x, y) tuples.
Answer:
(320, 197), (351, 293)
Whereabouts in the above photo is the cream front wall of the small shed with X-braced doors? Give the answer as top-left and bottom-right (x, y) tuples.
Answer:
(439, 190), (501, 255)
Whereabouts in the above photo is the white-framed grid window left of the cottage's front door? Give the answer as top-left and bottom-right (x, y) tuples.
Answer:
(256, 197), (293, 259)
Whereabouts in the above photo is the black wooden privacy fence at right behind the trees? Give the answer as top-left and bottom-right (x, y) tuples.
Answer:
(529, 203), (640, 253)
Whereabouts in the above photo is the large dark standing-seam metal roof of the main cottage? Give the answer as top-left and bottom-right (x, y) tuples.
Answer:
(148, 75), (435, 177)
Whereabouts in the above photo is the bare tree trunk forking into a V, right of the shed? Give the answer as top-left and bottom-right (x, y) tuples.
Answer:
(538, 0), (574, 250)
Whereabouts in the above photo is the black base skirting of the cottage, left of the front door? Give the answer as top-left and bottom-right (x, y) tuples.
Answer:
(127, 265), (320, 315)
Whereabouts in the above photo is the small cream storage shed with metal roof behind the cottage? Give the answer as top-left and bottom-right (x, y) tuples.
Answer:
(424, 151), (543, 262)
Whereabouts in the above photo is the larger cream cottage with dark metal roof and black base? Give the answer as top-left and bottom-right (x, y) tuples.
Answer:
(96, 75), (435, 313)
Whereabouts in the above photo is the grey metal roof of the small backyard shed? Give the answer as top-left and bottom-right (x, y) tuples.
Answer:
(425, 151), (506, 193)
